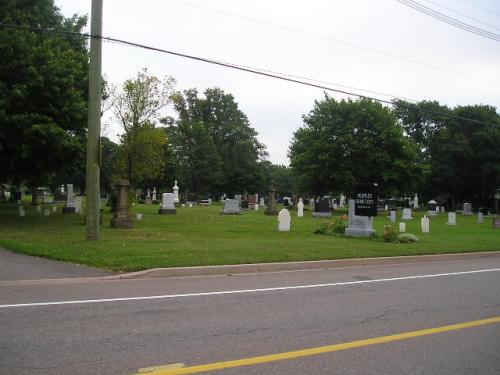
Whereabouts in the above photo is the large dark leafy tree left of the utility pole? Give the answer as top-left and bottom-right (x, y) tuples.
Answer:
(0, 0), (88, 197)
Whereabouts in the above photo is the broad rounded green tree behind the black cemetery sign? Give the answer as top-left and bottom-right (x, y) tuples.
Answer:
(289, 94), (421, 194)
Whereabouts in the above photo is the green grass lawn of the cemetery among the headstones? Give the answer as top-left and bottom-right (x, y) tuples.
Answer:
(0, 203), (500, 271)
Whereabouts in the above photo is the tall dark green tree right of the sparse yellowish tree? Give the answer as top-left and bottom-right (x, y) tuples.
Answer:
(169, 88), (265, 195)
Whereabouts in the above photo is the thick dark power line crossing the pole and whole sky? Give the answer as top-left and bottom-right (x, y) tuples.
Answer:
(0, 23), (500, 126)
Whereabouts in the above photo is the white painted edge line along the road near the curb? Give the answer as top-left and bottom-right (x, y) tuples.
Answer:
(0, 268), (500, 308)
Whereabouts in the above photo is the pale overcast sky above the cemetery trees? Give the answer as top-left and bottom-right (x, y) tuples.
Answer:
(56, 0), (500, 164)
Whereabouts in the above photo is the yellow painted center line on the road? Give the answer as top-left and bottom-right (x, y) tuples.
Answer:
(150, 316), (500, 375)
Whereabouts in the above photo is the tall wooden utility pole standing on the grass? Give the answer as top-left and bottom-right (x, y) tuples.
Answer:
(86, 0), (102, 241)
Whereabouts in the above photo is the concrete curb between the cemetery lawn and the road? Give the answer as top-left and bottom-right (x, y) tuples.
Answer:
(113, 251), (500, 280)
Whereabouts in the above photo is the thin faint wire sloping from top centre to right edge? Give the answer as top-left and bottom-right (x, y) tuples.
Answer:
(170, 0), (500, 85)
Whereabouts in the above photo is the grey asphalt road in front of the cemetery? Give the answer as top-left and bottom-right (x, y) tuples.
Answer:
(0, 257), (500, 374)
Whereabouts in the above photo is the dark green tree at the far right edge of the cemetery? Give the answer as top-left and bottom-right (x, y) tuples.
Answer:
(429, 105), (500, 206)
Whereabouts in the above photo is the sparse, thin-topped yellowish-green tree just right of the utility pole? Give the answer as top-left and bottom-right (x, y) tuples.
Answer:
(114, 69), (175, 186)
